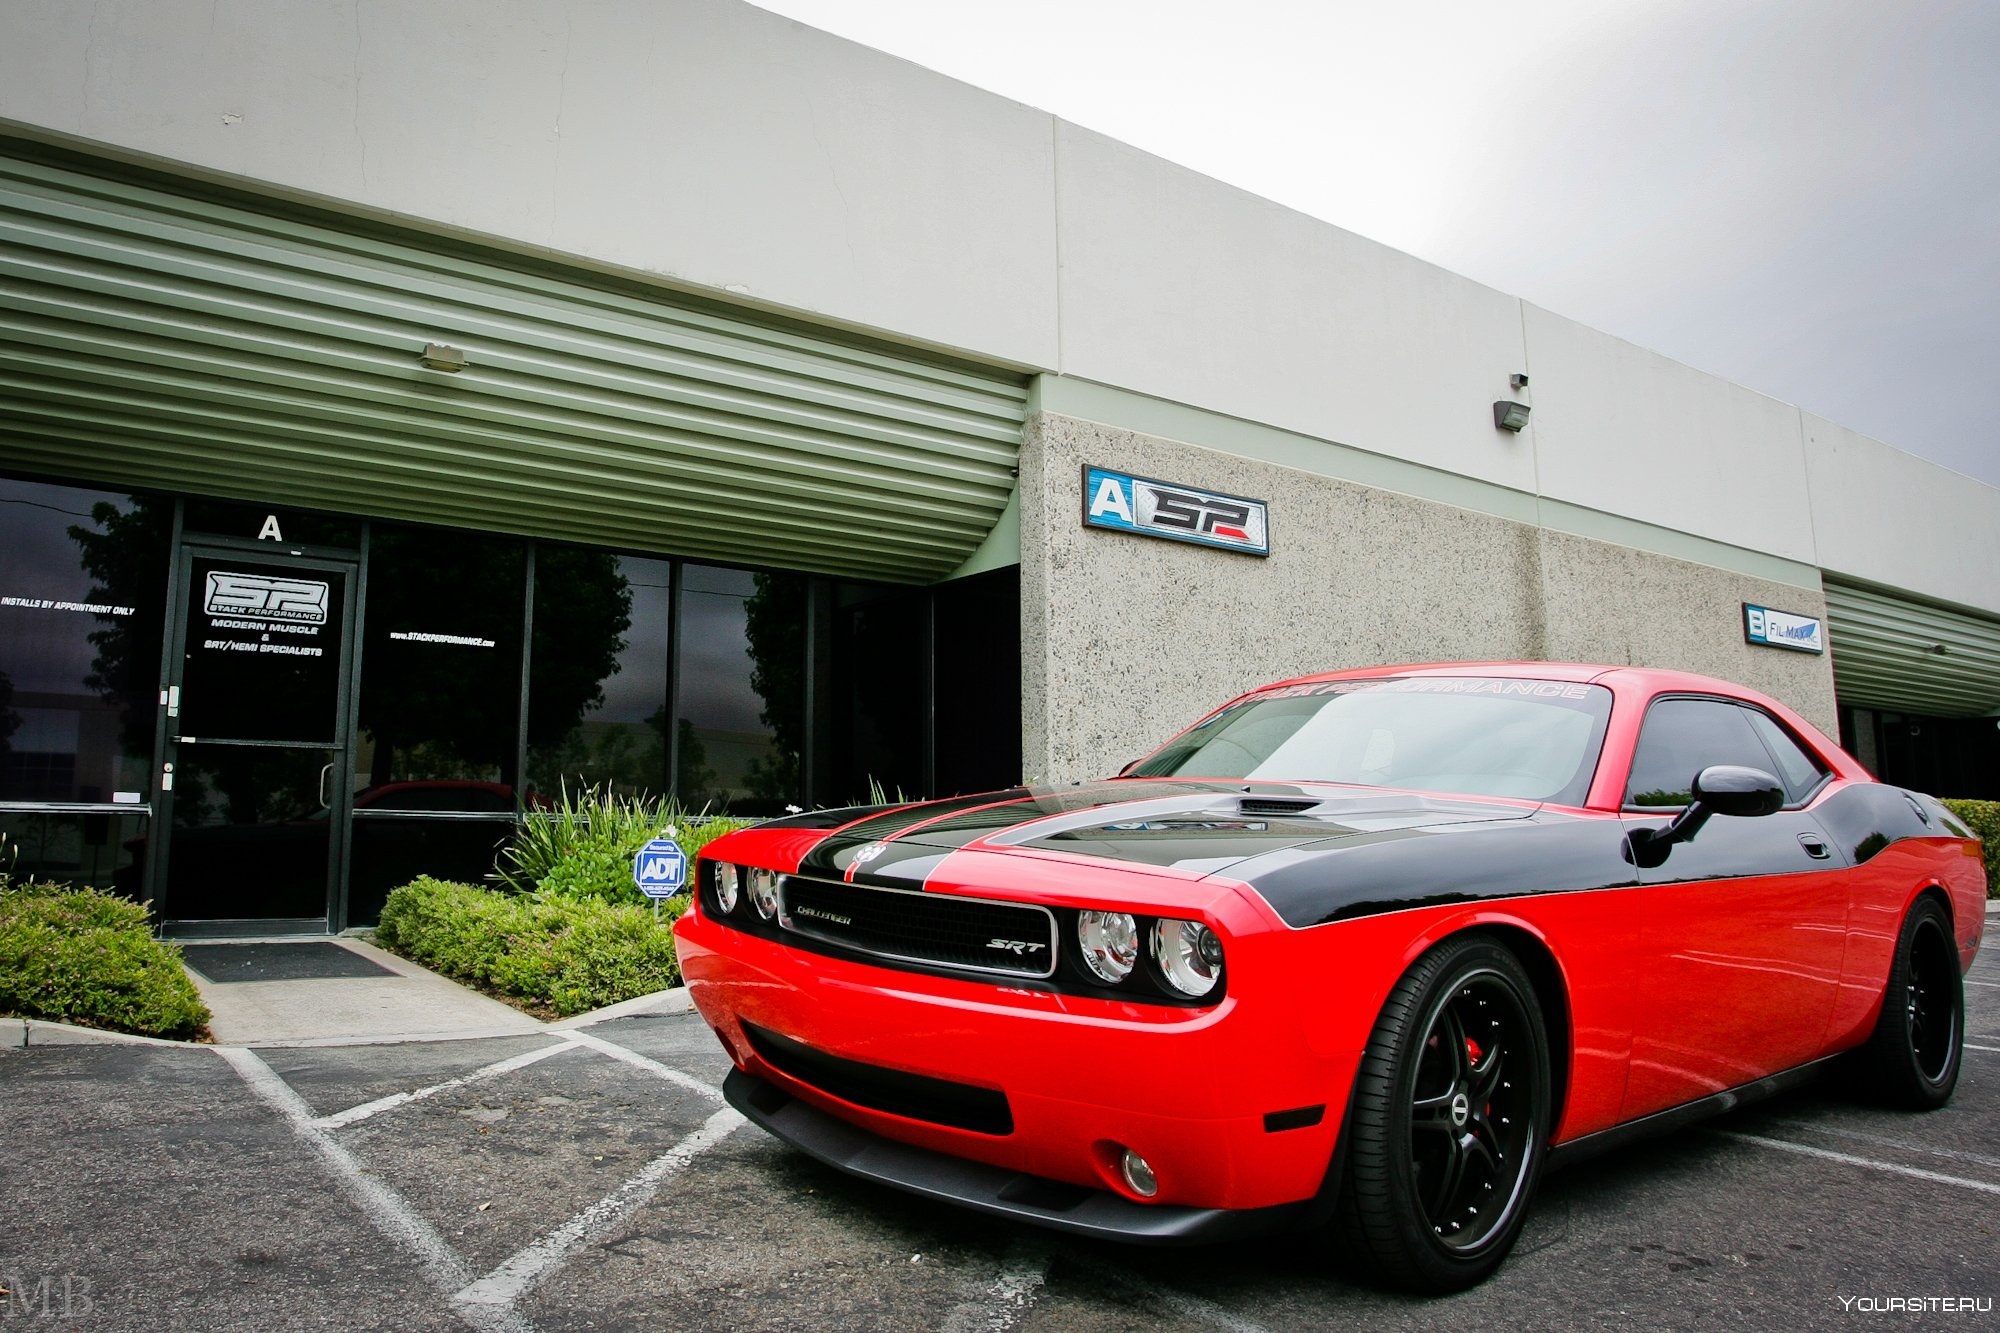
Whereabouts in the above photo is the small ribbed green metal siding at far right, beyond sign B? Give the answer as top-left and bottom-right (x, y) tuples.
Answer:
(1826, 578), (2000, 717)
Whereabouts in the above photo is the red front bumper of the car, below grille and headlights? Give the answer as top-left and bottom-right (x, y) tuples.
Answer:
(676, 915), (1360, 1216)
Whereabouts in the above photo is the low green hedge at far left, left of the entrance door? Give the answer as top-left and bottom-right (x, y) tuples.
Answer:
(0, 877), (210, 1039)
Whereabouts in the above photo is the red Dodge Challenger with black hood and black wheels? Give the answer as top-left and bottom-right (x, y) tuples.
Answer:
(676, 662), (1986, 1291)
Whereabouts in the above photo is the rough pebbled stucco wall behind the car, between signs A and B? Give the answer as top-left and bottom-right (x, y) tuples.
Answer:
(1020, 412), (1834, 783)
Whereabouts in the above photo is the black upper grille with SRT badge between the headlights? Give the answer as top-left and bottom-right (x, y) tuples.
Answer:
(778, 875), (1056, 977)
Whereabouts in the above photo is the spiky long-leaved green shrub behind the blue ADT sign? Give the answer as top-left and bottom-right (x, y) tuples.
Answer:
(498, 787), (750, 905)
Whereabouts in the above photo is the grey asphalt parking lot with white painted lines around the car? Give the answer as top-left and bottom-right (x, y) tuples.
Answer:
(0, 924), (2000, 1333)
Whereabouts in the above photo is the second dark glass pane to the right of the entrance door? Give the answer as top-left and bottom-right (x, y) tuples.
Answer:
(526, 546), (674, 797)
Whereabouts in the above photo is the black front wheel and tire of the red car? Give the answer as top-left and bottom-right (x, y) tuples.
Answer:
(1336, 935), (1554, 1293)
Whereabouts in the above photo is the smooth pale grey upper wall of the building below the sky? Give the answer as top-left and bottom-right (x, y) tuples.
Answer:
(0, 0), (2000, 632)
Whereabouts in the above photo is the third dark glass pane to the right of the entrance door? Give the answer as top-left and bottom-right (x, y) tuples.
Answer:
(674, 564), (808, 815)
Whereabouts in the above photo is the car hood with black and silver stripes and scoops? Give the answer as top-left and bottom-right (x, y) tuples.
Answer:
(800, 779), (1538, 881)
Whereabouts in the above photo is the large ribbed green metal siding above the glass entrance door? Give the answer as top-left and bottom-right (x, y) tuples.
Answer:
(0, 156), (1026, 582)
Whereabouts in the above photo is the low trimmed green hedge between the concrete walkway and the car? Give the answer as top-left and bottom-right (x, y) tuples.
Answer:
(376, 876), (686, 1017)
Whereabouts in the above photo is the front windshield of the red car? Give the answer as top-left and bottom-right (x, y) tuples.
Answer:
(1130, 677), (1612, 805)
